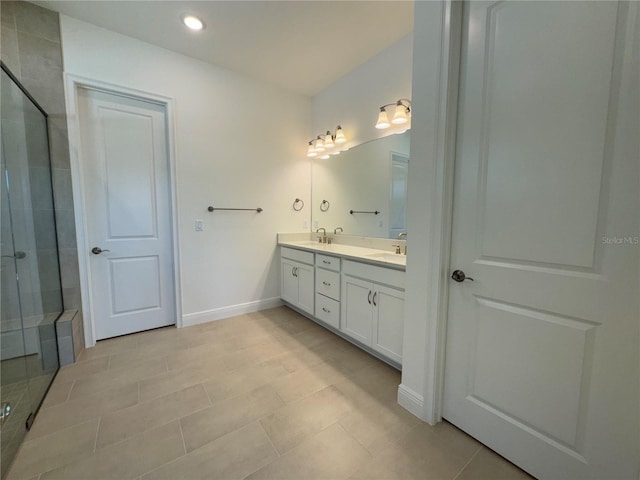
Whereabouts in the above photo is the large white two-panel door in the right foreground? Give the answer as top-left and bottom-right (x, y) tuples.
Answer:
(443, 2), (640, 480)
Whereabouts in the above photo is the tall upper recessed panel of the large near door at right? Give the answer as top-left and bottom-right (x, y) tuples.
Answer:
(476, 2), (617, 271)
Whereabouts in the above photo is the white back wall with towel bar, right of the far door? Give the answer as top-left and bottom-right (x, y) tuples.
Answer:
(61, 16), (311, 330)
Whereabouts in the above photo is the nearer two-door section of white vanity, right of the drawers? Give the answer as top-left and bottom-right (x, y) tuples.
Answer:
(340, 261), (404, 363)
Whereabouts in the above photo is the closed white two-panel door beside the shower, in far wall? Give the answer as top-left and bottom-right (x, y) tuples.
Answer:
(78, 89), (176, 340)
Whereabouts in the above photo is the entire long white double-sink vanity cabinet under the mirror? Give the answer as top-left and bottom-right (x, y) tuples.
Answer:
(280, 244), (405, 367)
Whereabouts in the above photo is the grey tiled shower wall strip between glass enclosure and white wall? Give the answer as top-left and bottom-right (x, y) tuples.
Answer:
(0, 0), (84, 364)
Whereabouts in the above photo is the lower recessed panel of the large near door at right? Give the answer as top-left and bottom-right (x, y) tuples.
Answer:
(466, 297), (599, 454)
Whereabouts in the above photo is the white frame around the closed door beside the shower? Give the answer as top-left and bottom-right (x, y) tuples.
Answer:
(64, 73), (183, 348)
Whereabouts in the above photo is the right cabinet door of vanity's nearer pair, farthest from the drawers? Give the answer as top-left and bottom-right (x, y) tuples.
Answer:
(371, 285), (404, 363)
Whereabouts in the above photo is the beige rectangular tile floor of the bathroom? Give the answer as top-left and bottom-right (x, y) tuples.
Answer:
(9, 307), (530, 480)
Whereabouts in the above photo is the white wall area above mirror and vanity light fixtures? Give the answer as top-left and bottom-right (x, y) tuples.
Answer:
(307, 34), (413, 150)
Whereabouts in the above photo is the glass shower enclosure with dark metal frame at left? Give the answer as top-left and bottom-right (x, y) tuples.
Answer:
(0, 65), (62, 477)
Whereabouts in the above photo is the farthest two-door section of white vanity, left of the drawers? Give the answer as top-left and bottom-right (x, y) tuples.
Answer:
(280, 247), (315, 315)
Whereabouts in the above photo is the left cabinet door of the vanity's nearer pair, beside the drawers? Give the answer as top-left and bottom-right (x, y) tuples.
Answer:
(340, 275), (373, 345)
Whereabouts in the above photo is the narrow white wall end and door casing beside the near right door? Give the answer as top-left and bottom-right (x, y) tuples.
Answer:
(398, 0), (465, 425)
